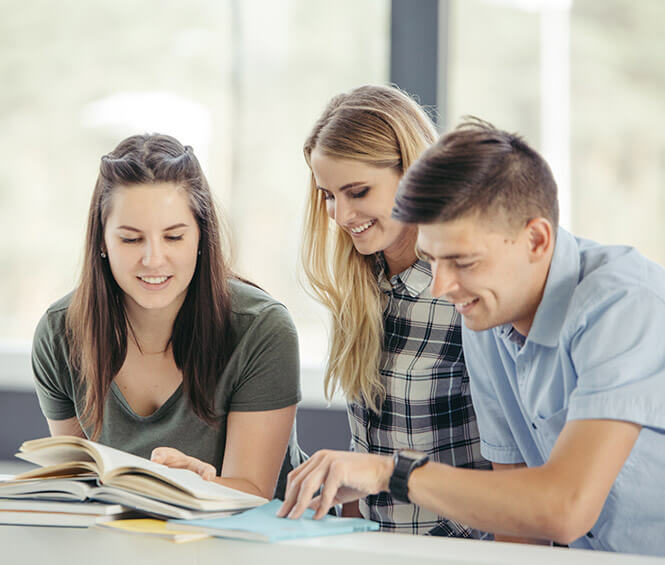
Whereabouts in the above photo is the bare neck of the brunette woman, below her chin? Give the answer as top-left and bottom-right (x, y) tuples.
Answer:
(125, 296), (184, 355)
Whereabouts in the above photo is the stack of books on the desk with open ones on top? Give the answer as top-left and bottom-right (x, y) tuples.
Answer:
(0, 436), (268, 527)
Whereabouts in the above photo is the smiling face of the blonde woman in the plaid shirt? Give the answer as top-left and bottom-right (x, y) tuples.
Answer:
(310, 149), (413, 255)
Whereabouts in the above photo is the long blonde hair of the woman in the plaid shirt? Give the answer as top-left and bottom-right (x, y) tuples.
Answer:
(302, 85), (437, 412)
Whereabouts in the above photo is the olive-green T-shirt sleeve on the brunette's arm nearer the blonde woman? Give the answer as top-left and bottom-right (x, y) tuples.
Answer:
(229, 304), (301, 412)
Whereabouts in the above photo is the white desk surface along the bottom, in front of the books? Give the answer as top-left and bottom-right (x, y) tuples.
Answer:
(0, 526), (665, 565)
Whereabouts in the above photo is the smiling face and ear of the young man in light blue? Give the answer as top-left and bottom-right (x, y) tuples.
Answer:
(418, 216), (554, 335)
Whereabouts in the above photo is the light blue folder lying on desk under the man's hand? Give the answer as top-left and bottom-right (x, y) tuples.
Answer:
(167, 500), (379, 542)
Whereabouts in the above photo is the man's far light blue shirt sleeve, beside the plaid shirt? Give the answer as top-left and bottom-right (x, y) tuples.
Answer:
(462, 323), (524, 464)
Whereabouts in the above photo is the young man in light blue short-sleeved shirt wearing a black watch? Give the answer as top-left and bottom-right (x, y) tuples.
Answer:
(281, 121), (665, 555)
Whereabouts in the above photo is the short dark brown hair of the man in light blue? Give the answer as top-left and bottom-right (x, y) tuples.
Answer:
(392, 117), (559, 230)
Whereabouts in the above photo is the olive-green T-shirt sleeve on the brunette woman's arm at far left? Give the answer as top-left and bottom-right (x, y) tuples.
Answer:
(32, 312), (76, 420)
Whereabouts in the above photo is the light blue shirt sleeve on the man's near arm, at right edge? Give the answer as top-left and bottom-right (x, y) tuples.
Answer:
(567, 289), (665, 430)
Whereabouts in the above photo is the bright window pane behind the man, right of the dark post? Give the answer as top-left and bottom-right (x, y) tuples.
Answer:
(447, 0), (665, 264)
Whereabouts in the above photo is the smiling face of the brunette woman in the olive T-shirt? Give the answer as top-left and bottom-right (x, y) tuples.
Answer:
(104, 183), (199, 317)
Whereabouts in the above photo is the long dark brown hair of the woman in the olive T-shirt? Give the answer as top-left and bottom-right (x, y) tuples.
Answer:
(67, 134), (231, 438)
